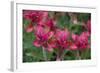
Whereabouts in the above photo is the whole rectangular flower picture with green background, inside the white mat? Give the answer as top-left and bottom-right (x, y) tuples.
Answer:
(23, 10), (91, 62)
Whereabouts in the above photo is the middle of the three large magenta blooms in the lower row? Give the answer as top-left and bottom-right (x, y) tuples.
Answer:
(55, 29), (69, 49)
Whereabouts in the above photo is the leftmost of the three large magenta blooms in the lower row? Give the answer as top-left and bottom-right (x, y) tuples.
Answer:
(33, 26), (54, 50)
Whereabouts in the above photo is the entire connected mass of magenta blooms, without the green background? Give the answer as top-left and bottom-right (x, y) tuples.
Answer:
(23, 10), (91, 60)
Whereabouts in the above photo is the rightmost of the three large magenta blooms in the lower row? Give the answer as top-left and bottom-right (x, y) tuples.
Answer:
(70, 32), (90, 50)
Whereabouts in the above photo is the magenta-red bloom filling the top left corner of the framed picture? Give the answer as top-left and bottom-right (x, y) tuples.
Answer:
(23, 10), (48, 24)
